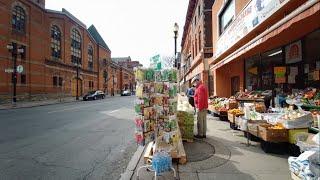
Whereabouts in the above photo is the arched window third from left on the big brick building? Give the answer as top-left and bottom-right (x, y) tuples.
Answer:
(71, 29), (82, 65)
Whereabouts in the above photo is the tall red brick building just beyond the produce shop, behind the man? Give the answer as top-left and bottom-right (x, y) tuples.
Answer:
(180, 0), (214, 95)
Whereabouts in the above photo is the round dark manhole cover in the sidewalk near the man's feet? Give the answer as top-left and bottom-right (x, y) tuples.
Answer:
(184, 139), (215, 162)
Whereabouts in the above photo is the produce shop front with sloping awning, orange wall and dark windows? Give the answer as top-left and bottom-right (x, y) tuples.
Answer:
(210, 1), (320, 97)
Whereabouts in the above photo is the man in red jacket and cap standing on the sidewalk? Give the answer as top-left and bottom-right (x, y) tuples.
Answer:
(191, 77), (208, 138)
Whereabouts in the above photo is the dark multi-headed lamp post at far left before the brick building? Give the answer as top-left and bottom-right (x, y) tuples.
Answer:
(7, 42), (24, 104)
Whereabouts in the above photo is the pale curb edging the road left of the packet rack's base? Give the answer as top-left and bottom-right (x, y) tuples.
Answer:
(120, 146), (146, 180)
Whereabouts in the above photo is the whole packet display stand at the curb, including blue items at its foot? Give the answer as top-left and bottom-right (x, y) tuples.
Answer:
(135, 68), (186, 179)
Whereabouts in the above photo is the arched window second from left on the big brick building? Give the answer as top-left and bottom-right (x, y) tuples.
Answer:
(51, 25), (61, 58)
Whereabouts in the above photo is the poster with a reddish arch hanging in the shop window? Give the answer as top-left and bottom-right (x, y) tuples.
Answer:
(286, 41), (302, 64)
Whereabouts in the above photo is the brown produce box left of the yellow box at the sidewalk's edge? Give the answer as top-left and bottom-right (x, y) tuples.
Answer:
(258, 124), (289, 142)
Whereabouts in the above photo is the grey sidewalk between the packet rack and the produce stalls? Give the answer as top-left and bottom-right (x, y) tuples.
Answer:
(121, 115), (291, 180)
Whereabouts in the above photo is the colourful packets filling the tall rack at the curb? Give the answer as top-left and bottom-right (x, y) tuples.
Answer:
(135, 68), (180, 152)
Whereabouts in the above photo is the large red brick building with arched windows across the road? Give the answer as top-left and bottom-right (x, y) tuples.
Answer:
(0, 0), (115, 100)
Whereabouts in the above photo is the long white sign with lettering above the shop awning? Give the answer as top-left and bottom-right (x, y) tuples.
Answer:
(215, 0), (289, 57)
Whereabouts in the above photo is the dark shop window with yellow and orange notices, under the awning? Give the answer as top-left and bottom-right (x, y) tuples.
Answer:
(244, 29), (320, 93)
